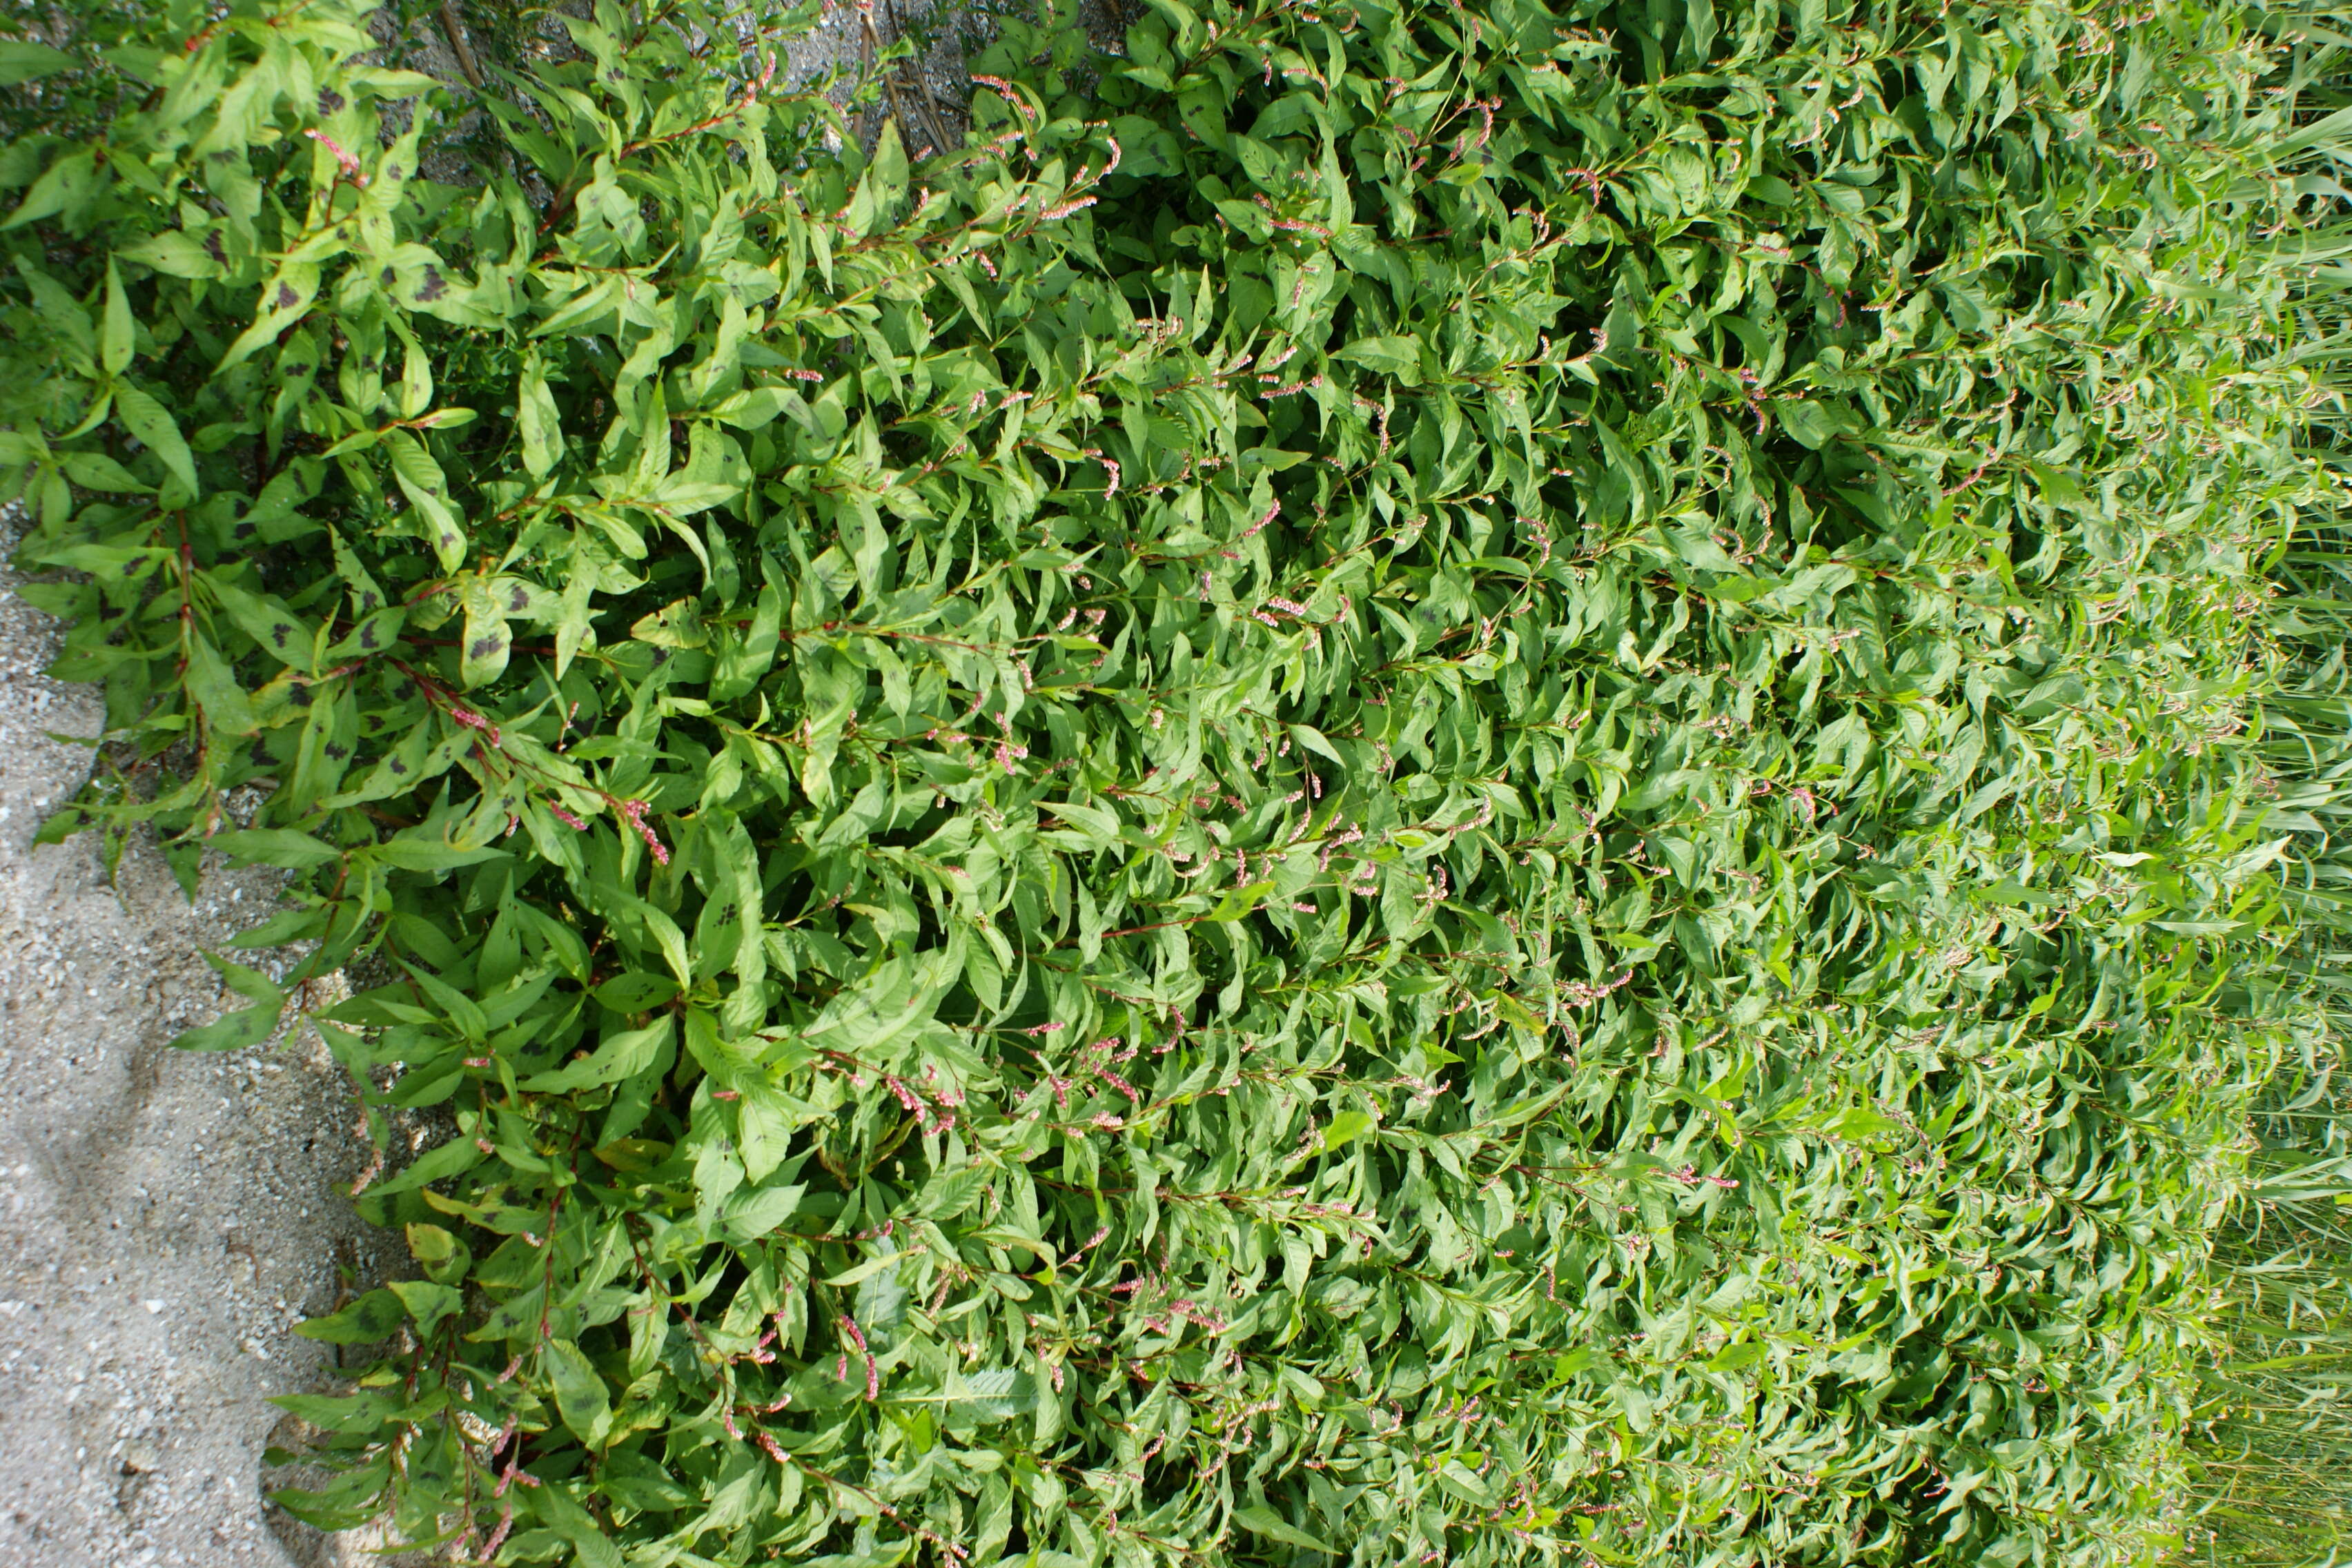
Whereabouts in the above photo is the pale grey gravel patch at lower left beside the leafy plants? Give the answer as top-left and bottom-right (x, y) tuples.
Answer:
(0, 522), (409, 1568)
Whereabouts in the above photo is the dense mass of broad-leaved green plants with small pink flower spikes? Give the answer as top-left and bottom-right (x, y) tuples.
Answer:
(0, 0), (2329, 1568)
